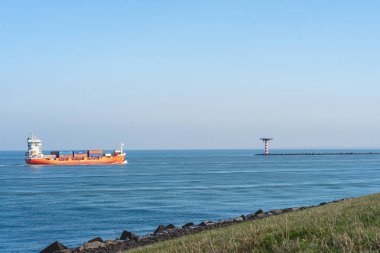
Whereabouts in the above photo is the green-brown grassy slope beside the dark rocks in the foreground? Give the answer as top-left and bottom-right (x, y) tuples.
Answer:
(128, 194), (380, 253)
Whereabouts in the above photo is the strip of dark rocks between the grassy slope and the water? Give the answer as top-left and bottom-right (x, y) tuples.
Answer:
(40, 198), (347, 253)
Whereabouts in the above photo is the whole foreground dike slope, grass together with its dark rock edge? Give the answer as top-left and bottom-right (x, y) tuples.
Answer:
(41, 194), (380, 253)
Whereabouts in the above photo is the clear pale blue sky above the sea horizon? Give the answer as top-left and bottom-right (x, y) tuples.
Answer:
(0, 0), (380, 150)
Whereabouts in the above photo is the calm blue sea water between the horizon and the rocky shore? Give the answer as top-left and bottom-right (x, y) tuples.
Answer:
(0, 150), (380, 252)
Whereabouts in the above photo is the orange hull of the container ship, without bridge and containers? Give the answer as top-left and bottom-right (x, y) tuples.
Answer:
(25, 154), (125, 165)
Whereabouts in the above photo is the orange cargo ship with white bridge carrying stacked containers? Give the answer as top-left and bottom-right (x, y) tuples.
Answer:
(25, 135), (127, 165)
